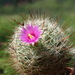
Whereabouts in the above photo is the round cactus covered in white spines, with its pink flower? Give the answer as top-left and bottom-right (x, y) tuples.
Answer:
(4, 11), (74, 75)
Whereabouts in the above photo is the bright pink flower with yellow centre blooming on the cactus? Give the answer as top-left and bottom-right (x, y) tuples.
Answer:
(20, 24), (42, 44)
